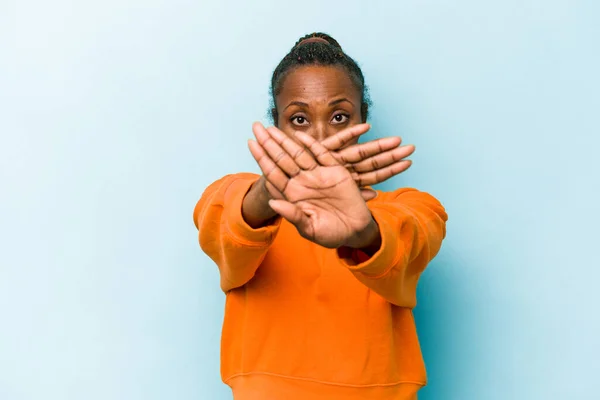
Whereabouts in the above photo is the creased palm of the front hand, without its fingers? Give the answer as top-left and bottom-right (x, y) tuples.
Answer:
(280, 165), (371, 248)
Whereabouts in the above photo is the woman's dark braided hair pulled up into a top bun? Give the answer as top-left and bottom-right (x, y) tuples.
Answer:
(271, 33), (371, 125)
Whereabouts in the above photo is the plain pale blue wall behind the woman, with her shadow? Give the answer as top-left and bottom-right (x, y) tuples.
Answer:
(0, 0), (600, 400)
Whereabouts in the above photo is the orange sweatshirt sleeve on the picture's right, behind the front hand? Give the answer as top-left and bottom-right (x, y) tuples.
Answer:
(336, 189), (448, 308)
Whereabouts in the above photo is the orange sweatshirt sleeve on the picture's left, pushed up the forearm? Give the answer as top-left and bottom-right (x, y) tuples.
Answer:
(194, 173), (281, 292)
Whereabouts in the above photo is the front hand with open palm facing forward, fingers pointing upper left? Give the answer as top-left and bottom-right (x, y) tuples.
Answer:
(248, 125), (379, 248)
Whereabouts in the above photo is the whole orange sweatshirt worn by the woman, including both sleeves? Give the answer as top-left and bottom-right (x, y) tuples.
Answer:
(194, 173), (447, 400)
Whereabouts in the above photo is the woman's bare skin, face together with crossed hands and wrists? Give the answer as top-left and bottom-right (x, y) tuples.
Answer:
(242, 66), (414, 253)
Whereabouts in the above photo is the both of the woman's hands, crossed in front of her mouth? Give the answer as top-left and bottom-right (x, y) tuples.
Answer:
(248, 123), (414, 248)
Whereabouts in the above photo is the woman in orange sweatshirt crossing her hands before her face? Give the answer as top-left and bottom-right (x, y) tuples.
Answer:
(194, 34), (447, 400)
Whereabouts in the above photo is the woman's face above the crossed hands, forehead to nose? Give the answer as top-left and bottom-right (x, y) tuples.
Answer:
(276, 66), (362, 145)
